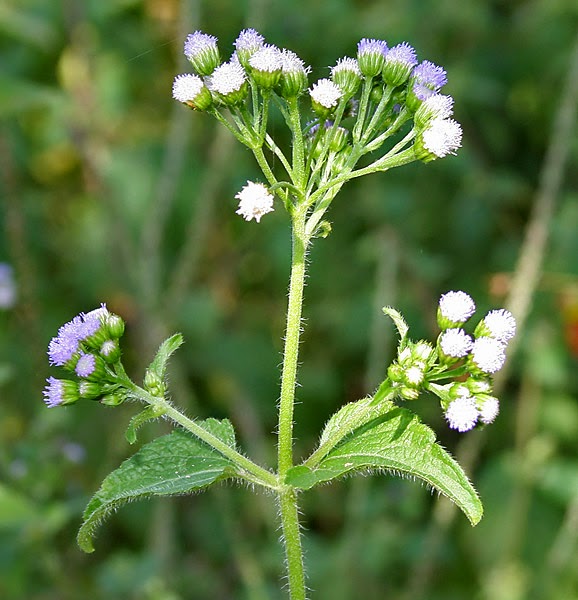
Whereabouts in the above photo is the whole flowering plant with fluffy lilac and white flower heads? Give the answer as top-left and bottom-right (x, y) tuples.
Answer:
(44, 29), (516, 600)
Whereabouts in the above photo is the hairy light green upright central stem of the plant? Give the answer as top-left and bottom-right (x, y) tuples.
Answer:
(278, 204), (309, 600)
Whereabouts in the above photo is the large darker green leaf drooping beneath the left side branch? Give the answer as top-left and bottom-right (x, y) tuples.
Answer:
(77, 419), (236, 552)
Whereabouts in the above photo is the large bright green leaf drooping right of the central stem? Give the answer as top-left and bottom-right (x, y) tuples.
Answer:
(285, 402), (483, 525)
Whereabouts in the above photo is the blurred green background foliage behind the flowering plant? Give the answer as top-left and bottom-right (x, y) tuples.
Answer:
(0, 0), (578, 600)
